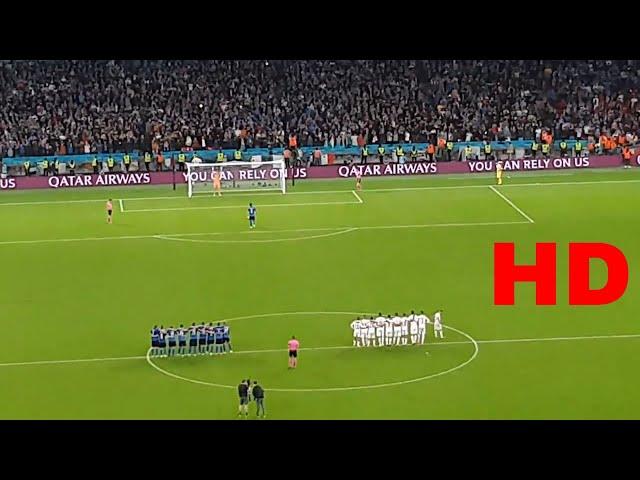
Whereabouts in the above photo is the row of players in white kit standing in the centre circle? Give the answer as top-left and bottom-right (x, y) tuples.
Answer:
(351, 310), (444, 347)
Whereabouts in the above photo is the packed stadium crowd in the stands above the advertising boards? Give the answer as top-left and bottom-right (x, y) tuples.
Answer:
(0, 60), (640, 157)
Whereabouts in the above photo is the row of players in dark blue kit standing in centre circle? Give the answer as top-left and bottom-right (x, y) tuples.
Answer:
(150, 322), (233, 357)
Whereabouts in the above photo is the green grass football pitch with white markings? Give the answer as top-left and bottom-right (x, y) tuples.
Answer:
(0, 170), (640, 419)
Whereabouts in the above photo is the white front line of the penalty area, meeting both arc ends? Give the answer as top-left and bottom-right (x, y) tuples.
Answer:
(0, 220), (529, 245)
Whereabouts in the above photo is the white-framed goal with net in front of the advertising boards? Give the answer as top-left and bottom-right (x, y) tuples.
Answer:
(187, 160), (287, 198)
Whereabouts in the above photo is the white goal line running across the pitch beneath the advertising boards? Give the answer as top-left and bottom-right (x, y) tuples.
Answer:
(0, 179), (640, 206)
